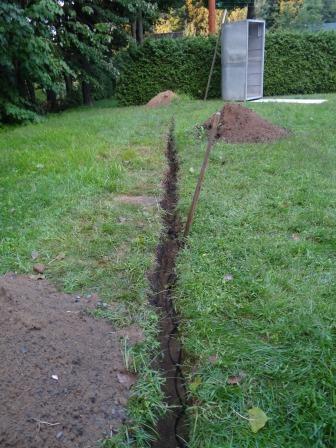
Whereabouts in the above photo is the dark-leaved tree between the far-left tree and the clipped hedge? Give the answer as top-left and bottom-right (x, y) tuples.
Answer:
(54, 0), (128, 105)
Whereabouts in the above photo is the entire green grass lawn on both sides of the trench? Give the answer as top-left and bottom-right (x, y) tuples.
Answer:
(0, 95), (336, 448)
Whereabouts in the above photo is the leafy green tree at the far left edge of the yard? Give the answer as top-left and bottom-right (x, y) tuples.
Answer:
(0, 0), (67, 121)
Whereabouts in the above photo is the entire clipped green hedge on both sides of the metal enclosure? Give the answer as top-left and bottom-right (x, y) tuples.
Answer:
(115, 31), (336, 104)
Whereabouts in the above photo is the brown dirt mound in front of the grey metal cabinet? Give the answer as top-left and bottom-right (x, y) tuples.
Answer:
(204, 103), (288, 143)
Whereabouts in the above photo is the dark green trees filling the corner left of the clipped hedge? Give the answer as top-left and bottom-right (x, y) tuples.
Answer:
(0, 0), (176, 122)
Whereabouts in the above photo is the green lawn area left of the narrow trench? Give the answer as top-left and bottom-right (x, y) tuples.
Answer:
(0, 102), (170, 446)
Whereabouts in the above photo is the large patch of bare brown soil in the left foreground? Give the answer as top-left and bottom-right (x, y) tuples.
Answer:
(0, 274), (132, 448)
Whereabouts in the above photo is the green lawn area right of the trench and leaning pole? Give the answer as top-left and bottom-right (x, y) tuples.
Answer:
(176, 96), (336, 448)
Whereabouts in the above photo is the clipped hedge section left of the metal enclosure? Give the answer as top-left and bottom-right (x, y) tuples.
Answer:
(116, 37), (220, 104)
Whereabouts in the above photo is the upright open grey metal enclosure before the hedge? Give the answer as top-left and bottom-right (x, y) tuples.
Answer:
(222, 20), (265, 101)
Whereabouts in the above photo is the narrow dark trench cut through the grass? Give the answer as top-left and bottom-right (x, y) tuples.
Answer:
(150, 123), (188, 448)
